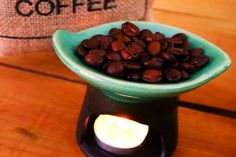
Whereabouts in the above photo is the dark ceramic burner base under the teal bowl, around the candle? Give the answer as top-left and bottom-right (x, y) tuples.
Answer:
(77, 86), (178, 157)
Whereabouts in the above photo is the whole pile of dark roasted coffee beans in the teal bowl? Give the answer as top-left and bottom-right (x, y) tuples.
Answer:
(76, 22), (209, 83)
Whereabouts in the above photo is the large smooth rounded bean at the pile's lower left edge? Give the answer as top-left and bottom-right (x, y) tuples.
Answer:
(84, 53), (104, 68)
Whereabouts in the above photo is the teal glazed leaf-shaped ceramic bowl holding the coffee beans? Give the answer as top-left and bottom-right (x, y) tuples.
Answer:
(53, 21), (231, 103)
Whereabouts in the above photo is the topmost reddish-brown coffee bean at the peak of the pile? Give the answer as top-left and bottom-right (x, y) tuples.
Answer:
(122, 22), (140, 37)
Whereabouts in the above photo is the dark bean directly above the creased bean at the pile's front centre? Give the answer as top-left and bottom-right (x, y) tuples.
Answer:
(143, 57), (164, 70)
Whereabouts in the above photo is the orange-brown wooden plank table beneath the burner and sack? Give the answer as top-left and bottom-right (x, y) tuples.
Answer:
(0, 0), (236, 157)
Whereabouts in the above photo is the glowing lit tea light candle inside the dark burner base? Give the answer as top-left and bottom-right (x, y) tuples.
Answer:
(94, 115), (149, 154)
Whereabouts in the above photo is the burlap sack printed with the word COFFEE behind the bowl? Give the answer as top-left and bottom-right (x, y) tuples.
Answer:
(0, 0), (153, 55)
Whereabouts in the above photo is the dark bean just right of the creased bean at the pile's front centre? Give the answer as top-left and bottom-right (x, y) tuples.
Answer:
(164, 68), (182, 82)
